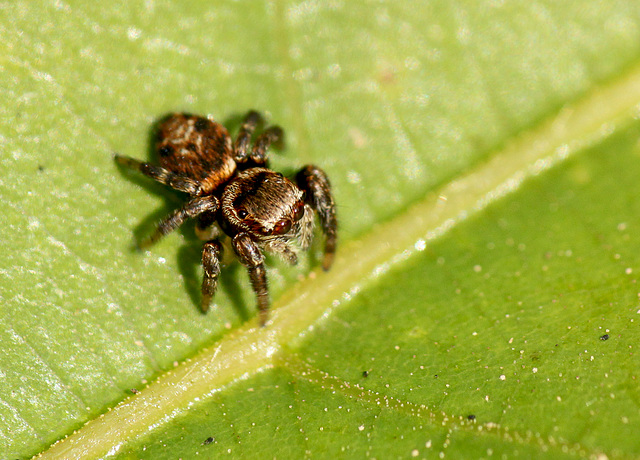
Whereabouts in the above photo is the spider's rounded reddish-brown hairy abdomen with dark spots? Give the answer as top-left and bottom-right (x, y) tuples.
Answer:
(156, 113), (236, 195)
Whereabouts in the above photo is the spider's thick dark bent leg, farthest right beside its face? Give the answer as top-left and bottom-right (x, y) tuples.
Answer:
(296, 165), (338, 270)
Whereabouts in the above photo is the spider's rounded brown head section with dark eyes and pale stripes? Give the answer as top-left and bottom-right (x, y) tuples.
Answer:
(222, 168), (305, 242)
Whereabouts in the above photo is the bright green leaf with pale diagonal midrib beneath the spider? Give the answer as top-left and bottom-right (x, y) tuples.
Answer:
(0, 1), (640, 459)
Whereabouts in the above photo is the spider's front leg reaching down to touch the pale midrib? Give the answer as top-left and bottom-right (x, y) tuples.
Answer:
(233, 233), (269, 326)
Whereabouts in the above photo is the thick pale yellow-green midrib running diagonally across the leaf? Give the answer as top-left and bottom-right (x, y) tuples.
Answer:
(41, 67), (640, 459)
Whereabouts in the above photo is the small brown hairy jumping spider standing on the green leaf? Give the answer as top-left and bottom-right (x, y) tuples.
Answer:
(115, 111), (337, 325)
